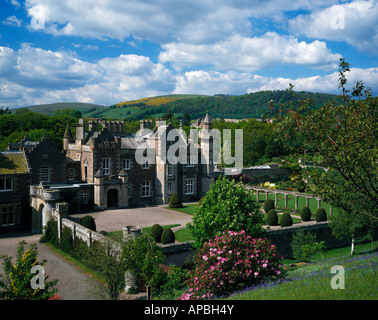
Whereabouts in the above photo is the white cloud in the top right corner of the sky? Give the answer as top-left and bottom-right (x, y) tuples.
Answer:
(289, 0), (378, 54)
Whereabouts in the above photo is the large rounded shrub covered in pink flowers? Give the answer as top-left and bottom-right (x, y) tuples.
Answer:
(181, 230), (282, 300)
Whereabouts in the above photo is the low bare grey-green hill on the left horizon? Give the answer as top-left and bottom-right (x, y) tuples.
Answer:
(11, 102), (106, 116)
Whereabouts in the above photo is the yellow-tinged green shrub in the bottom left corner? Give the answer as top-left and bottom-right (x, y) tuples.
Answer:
(0, 241), (58, 300)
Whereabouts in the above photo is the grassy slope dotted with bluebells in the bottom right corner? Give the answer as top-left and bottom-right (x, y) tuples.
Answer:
(228, 244), (378, 300)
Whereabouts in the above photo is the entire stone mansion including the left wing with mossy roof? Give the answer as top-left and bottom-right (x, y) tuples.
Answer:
(0, 114), (216, 232)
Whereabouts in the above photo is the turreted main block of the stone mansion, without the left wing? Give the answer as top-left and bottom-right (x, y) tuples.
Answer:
(63, 116), (213, 209)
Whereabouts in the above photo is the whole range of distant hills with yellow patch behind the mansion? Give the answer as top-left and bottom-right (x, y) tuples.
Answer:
(12, 90), (341, 120)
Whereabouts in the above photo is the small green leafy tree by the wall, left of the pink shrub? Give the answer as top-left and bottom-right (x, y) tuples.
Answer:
(121, 234), (164, 296)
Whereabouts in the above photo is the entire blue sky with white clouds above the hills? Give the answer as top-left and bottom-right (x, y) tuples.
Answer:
(0, 0), (378, 108)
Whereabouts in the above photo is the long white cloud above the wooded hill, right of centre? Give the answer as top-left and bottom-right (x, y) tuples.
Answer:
(159, 32), (341, 72)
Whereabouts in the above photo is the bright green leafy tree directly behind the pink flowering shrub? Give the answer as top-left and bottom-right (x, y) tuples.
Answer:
(188, 177), (263, 248)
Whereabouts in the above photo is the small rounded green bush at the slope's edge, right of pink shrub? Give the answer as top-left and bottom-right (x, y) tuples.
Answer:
(291, 230), (325, 262)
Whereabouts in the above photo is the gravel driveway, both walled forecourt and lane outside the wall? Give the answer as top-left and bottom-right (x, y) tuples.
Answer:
(0, 205), (192, 300)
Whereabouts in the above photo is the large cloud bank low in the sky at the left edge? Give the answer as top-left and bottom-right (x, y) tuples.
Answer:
(0, 44), (174, 106)
